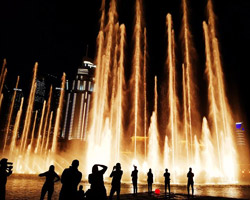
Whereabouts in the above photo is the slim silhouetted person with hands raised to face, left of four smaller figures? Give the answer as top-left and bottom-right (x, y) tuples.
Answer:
(109, 163), (123, 199)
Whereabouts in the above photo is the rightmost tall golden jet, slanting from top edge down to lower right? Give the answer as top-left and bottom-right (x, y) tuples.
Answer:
(207, 0), (237, 181)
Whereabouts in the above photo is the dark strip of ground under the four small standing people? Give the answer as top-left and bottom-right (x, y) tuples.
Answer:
(117, 193), (248, 200)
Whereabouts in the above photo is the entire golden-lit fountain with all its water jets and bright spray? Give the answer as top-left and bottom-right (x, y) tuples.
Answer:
(0, 0), (240, 183)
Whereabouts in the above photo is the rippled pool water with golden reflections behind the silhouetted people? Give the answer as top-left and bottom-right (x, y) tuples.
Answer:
(6, 174), (250, 200)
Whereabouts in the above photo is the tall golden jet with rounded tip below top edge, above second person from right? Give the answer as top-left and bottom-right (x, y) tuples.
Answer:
(166, 14), (178, 182)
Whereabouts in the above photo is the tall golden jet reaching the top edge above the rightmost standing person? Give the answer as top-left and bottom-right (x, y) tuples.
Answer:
(181, 0), (200, 165)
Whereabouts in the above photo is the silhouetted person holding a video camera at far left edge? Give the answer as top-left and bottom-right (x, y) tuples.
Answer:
(0, 158), (13, 200)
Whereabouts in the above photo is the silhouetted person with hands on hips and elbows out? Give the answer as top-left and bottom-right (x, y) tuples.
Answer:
(39, 165), (60, 200)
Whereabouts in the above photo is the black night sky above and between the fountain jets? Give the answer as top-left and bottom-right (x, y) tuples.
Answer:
(0, 0), (250, 127)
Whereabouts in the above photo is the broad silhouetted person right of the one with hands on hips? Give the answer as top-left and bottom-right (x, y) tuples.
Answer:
(59, 160), (82, 200)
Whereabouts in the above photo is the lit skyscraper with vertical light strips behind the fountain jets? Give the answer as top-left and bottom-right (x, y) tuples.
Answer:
(62, 57), (96, 140)
